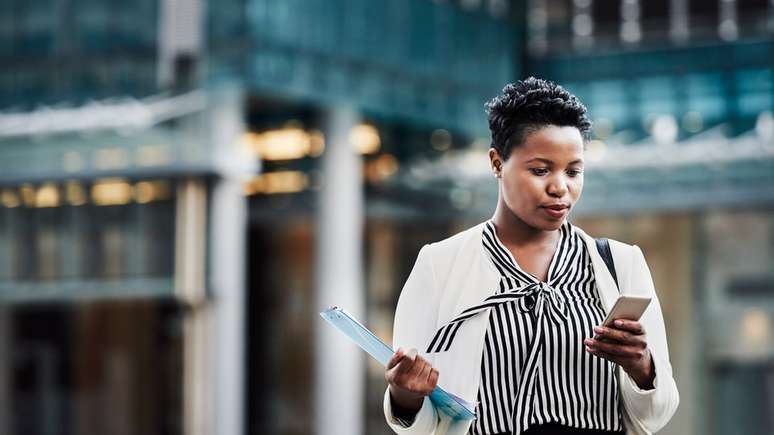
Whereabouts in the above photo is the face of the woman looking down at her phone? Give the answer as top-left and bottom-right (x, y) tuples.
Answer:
(489, 125), (583, 231)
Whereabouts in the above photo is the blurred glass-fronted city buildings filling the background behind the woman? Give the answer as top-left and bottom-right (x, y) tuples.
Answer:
(0, 0), (774, 435)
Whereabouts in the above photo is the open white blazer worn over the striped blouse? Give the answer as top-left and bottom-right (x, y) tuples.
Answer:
(384, 223), (680, 435)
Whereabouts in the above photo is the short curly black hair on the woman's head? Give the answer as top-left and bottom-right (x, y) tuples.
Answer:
(486, 77), (591, 160)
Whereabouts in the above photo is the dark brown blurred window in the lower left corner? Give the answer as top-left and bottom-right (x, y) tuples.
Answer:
(9, 301), (183, 435)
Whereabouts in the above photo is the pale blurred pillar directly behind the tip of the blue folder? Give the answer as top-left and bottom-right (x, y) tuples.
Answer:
(315, 108), (366, 435)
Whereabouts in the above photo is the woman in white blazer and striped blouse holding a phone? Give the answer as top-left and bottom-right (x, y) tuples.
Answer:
(384, 78), (679, 435)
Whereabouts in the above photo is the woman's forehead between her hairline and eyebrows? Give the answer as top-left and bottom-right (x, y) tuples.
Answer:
(511, 125), (583, 162)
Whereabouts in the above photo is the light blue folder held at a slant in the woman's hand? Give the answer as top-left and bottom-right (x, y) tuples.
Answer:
(320, 306), (476, 420)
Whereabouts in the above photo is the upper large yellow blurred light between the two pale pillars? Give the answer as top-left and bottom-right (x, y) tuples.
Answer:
(242, 128), (311, 160)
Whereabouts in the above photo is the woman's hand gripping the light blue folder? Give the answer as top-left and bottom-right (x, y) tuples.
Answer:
(384, 348), (438, 414)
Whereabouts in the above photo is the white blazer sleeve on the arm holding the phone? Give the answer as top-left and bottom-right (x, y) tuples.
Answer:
(619, 246), (680, 432)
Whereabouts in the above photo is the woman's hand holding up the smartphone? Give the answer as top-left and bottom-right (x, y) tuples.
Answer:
(583, 319), (656, 390)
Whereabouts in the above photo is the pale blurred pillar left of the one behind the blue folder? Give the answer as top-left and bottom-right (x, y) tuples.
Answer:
(207, 89), (258, 435)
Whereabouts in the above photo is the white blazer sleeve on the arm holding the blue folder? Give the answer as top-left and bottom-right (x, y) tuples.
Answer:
(384, 245), (439, 435)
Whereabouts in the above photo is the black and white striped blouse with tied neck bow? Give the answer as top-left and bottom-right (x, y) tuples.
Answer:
(428, 221), (623, 435)
